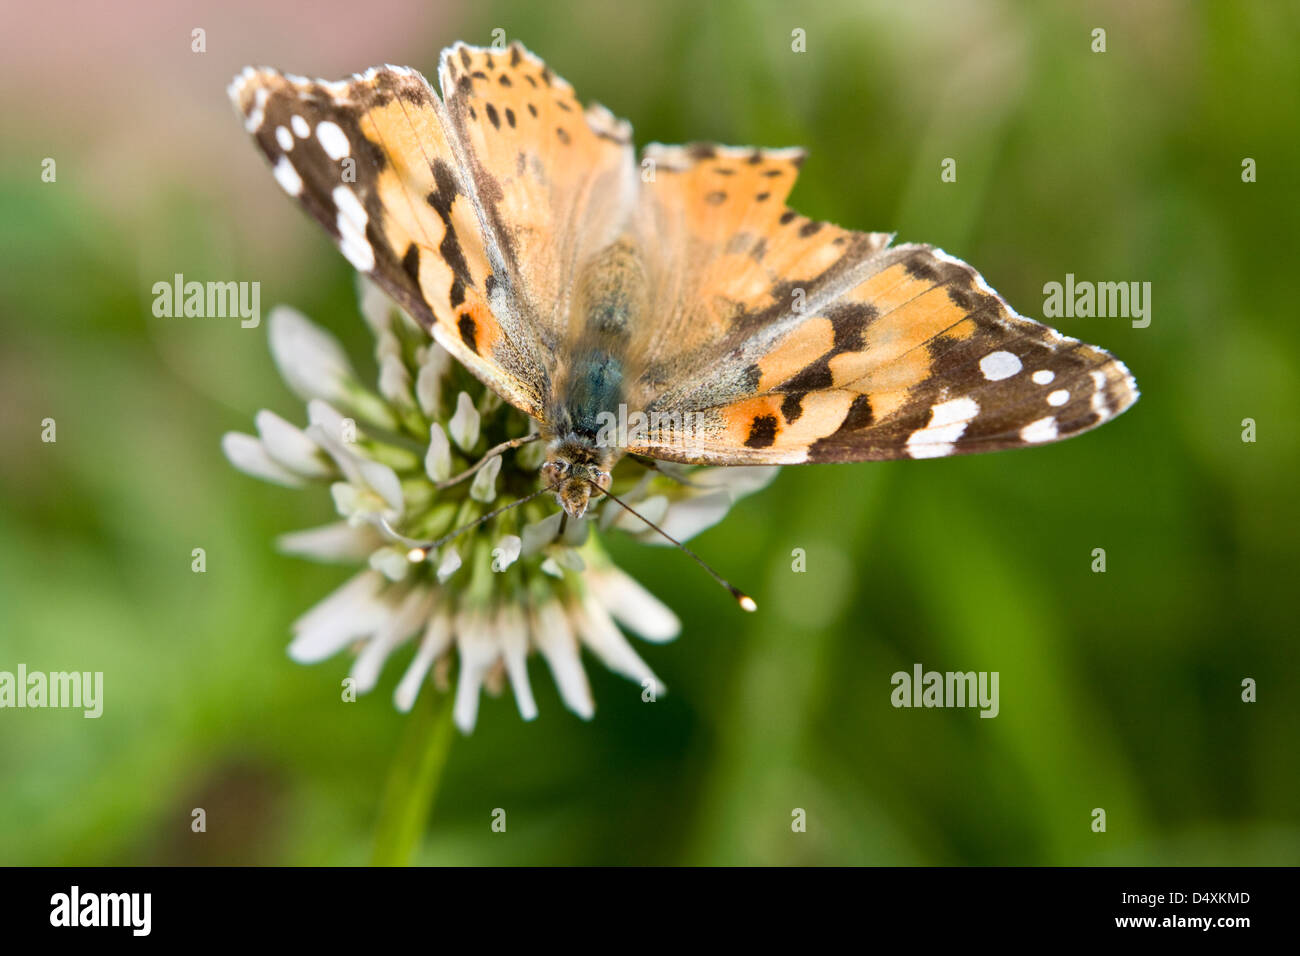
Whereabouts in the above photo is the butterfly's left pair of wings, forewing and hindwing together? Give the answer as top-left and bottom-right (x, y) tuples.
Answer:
(230, 44), (636, 420)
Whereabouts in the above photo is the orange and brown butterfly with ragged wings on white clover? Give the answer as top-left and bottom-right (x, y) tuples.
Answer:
(230, 43), (1138, 530)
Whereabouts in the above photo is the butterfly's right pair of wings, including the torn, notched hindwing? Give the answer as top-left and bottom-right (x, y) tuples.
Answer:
(628, 146), (1138, 464)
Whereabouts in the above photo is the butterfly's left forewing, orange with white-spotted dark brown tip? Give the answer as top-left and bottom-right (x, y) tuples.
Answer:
(230, 60), (546, 415)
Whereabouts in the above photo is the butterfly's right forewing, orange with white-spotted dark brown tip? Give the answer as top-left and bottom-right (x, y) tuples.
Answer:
(631, 238), (1138, 464)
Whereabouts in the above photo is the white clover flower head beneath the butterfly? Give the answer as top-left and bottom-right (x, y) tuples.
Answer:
(222, 281), (776, 734)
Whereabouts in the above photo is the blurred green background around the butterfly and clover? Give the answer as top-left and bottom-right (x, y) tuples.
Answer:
(0, 0), (1300, 865)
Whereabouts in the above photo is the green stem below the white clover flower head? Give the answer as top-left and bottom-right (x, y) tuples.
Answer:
(372, 687), (455, 866)
